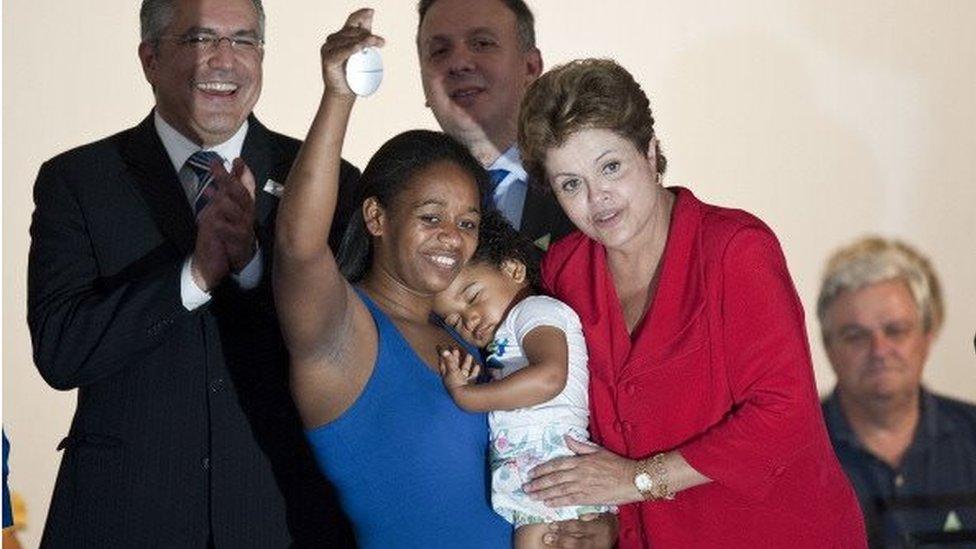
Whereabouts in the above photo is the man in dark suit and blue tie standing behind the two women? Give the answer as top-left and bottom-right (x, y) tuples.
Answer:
(417, 0), (575, 250)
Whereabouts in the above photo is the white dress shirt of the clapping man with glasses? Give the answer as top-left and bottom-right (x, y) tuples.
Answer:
(153, 111), (264, 311)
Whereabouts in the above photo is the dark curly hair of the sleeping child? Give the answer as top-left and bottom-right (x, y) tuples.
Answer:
(468, 208), (541, 290)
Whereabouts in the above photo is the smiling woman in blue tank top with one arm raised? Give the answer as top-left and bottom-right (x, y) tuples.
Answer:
(274, 10), (511, 548)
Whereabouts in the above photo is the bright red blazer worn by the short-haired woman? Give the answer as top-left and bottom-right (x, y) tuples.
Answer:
(542, 188), (866, 549)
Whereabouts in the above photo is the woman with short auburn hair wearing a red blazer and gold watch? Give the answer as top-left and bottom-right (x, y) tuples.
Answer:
(519, 60), (866, 549)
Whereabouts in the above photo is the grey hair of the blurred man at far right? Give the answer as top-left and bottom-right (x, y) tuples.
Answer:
(817, 236), (945, 334)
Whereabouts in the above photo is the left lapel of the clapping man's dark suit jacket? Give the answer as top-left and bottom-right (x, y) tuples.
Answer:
(122, 114), (196, 254)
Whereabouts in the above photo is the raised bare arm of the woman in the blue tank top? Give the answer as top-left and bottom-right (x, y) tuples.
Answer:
(274, 9), (383, 367)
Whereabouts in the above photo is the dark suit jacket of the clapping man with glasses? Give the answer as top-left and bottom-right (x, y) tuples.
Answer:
(28, 116), (358, 548)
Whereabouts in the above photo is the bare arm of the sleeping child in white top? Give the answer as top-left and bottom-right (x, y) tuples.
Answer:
(439, 326), (569, 412)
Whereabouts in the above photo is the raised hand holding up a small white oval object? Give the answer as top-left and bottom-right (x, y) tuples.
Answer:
(320, 8), (385, 98)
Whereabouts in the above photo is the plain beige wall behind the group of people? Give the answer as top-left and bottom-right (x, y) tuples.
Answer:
(3, 0), (976, 546)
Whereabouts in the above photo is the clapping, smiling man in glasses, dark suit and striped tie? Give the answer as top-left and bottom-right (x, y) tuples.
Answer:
(28, 0), (358, 548)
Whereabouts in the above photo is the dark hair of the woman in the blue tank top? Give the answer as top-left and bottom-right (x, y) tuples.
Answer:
(336, 130), (488, 282)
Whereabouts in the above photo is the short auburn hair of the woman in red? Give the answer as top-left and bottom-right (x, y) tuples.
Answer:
(518, 59), (668, 187)
